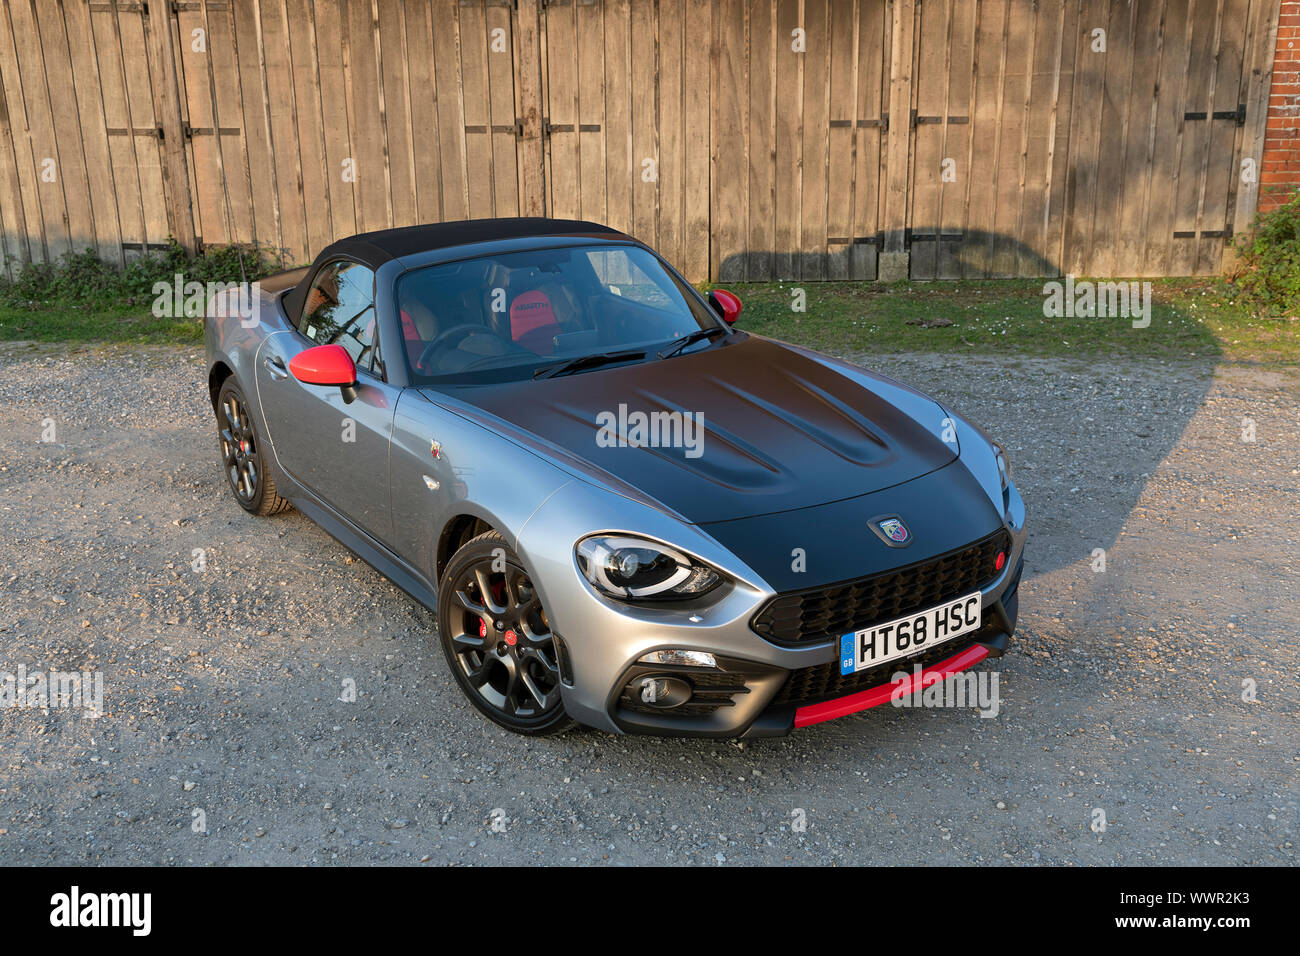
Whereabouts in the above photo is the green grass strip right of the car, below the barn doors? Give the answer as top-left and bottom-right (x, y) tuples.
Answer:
(727, 278), (1300, 364)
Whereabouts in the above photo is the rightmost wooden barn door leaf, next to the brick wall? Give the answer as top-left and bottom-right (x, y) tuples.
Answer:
(1062, 0), (1275, 276)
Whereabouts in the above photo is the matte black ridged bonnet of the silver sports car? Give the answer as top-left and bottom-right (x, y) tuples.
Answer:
(430, 336), (957, 523)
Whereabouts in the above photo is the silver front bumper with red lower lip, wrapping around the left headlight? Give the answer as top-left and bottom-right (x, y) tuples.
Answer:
(516, 481), (1026, 737)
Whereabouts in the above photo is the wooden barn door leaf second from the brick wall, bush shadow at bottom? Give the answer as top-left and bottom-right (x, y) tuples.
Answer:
(906, 0), (1075, 278)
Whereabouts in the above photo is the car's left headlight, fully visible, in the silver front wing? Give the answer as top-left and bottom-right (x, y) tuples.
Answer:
(575, 535), (722, 601)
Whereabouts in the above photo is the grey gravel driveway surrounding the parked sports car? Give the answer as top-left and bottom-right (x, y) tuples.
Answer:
(0, 347), (1300, 865)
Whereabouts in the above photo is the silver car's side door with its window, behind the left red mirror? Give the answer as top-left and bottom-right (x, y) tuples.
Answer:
(256, 259), (400, 544)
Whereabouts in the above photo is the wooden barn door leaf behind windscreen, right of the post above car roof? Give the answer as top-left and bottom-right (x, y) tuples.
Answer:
(542, 0), (714, 280)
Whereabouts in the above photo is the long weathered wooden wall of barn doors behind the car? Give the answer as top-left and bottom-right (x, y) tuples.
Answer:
(0, 0), (1278, 281)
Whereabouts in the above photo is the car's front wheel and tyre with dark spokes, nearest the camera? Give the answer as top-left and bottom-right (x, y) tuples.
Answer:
(438, 531), (575, 736)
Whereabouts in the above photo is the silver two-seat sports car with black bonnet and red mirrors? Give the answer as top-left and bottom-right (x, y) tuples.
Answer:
(205, 219), (1024, 737)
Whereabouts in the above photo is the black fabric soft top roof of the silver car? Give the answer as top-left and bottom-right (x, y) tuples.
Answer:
(285, 216), (625, 321)
